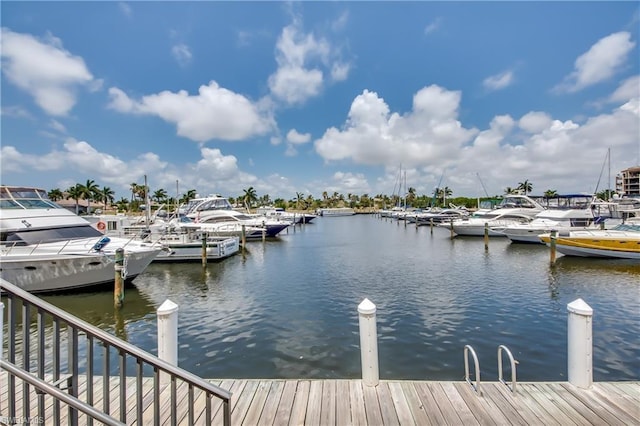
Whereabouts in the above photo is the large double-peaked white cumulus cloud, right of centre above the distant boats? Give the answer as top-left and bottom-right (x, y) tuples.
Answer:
(315, 85), (476, 167)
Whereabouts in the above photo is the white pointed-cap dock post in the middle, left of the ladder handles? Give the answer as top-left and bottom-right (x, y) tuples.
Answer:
(358, 298), (379, 386)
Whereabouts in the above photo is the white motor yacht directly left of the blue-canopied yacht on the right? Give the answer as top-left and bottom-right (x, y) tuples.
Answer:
(439, 194), (545, 237)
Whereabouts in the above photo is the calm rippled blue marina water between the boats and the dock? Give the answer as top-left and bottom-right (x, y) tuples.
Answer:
(37, 215), (640, 381)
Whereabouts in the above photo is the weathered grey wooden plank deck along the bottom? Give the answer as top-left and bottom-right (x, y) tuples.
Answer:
(0, 372), (640, 426)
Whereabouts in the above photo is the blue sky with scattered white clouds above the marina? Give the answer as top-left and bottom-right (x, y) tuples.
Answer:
(0, 1), (640, 199)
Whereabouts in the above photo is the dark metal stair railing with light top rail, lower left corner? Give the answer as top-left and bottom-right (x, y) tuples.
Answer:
(0, 279), (231, 426)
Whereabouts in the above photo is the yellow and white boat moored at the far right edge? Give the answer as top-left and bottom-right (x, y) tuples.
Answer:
(539, 221), (640, 260)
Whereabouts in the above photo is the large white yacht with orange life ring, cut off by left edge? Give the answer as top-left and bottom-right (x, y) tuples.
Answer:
(0, 186), (162, 293)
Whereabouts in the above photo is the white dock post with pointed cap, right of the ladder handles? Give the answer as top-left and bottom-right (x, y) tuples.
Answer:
(567, 299), (593, 389)
